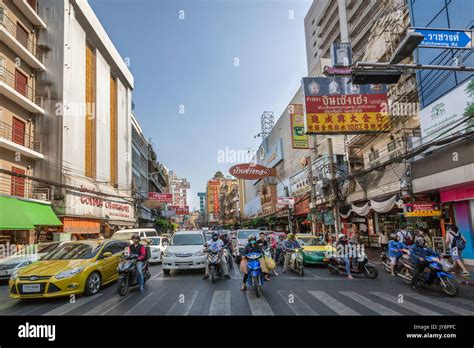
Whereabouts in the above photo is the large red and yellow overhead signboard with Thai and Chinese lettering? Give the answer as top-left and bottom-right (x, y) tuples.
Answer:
(303, 77), (390, 134)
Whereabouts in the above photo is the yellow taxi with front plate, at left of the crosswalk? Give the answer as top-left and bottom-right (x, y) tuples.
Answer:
(9, 240), (129, 298)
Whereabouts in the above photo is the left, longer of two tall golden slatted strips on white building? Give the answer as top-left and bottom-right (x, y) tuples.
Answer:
(85, 45), (96, 179)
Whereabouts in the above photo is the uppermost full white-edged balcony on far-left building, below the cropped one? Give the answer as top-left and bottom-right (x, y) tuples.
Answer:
(0, 14), (46, 71)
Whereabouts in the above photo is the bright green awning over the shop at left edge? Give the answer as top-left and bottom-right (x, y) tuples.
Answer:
(0, 196), (62, 230)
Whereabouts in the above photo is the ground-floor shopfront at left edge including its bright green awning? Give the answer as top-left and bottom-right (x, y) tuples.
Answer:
(0, 196), (62, 257)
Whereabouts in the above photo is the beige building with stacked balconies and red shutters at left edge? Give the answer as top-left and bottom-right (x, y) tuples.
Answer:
(0, 0), (61, 245)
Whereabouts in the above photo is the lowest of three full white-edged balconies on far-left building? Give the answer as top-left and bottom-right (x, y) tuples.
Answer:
(0, 121), (44, 159)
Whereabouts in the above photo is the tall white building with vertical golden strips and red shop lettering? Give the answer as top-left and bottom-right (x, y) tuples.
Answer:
(36, 0), (136, 235)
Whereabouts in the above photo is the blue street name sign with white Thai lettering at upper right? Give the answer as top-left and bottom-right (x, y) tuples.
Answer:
(414, 28), (472, 49)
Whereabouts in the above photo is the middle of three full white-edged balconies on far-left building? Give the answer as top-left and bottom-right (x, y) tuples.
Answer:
(0, 67), (45, 115)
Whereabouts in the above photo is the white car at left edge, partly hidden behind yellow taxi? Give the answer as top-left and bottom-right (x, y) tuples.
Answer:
(0, 242), (61, 280)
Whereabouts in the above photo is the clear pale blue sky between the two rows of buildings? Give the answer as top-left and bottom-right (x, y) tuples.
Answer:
(89, 0), (312, 209)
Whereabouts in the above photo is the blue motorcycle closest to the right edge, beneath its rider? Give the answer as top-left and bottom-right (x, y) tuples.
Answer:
(398, 256), (459, 297)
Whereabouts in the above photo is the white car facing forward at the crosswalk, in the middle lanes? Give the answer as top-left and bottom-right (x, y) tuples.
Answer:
(162, 231), (207, 275)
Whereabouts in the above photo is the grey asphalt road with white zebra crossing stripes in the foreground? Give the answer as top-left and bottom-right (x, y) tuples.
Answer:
(0, 264), (474, 315)
